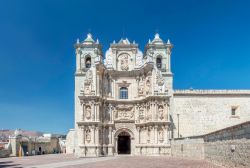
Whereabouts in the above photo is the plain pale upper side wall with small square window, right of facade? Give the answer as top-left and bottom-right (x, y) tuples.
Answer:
(172, 90), (250, 138)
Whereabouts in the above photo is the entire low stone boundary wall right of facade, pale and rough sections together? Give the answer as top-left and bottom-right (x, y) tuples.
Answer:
(171, 122), (250, 168)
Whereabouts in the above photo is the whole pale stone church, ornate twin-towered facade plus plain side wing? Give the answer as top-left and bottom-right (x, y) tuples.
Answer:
(66, 34), (250, 157)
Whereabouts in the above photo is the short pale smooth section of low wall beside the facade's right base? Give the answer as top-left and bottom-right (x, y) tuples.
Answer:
(171, 137), (204, 159)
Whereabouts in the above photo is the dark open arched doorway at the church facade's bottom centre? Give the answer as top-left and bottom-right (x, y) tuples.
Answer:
(117, 131), (131, 154)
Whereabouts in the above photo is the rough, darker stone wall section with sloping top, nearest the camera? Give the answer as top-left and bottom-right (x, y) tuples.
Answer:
(204, 121), (250, 167)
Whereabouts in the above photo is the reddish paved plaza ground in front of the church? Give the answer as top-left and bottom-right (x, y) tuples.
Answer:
(0, 154), (225, 168)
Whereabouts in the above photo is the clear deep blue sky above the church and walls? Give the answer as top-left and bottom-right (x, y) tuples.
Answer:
(0, 0), (250, 133)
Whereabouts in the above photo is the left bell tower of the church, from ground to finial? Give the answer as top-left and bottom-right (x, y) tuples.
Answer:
(74, 33), (103, 157)
